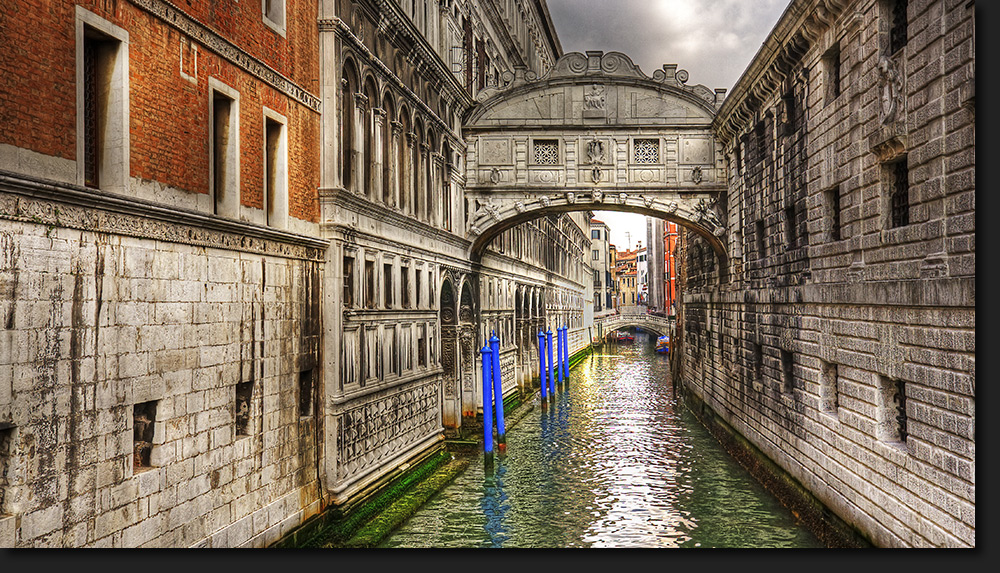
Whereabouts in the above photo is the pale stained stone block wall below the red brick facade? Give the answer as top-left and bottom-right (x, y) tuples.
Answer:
(0, 196), (320, 547)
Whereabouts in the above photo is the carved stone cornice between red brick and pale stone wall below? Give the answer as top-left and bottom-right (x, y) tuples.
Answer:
(0, 171), (330, 260)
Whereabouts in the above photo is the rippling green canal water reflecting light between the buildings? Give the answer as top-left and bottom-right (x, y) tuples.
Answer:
(380, 332), (822, 548)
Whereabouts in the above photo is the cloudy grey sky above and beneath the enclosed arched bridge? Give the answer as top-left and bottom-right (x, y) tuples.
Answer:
(547, 0), (789, 249)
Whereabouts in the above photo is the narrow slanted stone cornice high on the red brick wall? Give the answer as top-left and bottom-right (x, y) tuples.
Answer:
(130, 0), (322, 113)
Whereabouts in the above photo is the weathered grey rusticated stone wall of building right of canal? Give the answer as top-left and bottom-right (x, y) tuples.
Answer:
(683, 1), (976, 547)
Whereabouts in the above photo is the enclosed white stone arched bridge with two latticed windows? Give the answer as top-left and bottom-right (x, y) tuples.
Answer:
(463, 51), (728, 269)
